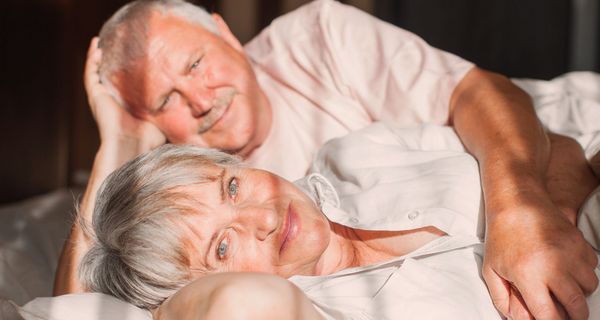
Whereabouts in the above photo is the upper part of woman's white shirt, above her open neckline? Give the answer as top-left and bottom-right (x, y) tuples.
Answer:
(304, 122), (484, 237)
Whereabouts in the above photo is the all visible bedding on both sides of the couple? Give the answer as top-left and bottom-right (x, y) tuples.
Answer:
(0, 72), (600, 320)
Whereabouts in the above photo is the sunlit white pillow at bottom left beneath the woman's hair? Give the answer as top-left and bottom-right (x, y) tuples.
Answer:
(19, 293), (152, 320)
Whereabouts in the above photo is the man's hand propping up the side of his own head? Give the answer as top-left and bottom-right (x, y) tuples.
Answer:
(84, 37), (166, 153)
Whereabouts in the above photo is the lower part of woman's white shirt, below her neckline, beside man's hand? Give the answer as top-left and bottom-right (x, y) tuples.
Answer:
(289, 236), (502, 320)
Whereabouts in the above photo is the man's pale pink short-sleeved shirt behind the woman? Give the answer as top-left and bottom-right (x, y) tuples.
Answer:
(245, 0), (473, 180)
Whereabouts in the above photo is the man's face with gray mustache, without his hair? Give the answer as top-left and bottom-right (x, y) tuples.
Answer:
(111, 13), (271, 155)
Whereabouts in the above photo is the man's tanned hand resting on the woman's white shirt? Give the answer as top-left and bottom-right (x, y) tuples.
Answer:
(483, 197), (598, 319)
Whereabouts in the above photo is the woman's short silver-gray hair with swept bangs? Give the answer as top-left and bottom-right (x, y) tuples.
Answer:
(79, 145), (240, 309)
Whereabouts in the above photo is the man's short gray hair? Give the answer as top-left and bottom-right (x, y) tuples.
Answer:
(98, 0), (219, 114)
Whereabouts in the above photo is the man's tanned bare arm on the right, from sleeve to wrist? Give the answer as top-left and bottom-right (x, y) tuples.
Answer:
(450, 69), (550, 218)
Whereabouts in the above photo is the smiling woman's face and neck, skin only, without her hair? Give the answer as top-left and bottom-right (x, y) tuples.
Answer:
(178, 167), (445, 278)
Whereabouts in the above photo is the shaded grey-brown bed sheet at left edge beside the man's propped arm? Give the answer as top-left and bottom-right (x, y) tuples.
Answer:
(0, 189), (79, 304)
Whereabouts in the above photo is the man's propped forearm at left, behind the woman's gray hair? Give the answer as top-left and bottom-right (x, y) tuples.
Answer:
(53, 141), (148, 295)
